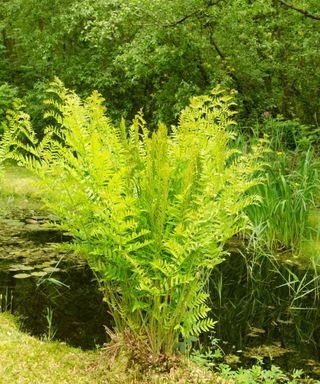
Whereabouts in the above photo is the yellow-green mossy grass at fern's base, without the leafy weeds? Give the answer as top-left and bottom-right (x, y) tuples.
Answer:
(0, 313), (228, 384)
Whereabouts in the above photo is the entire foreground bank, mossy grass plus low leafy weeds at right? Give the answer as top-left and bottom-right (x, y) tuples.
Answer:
(0, 313), (320, 384)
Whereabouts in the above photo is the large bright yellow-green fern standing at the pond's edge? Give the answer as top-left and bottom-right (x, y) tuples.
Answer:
(12, 80), (261, 354)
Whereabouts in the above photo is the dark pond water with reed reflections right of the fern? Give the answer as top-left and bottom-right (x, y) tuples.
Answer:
(210, 241), (320, 379)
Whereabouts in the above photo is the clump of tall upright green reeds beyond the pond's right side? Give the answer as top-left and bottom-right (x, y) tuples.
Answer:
(247, 148), (319, 254)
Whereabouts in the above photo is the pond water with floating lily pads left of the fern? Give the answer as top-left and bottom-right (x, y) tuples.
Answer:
(0, 208), (111, 349)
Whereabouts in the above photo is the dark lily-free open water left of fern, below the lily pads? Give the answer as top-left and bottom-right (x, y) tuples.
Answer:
(0, 264), (111, 349)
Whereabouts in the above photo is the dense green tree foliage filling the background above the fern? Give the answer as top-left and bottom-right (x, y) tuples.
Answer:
(0, 0), (320, 130)
